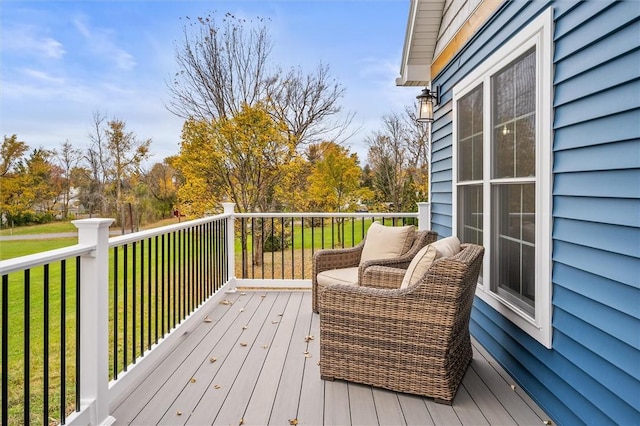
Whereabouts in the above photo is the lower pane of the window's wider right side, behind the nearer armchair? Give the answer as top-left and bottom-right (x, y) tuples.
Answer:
(491, 183), (536, 316)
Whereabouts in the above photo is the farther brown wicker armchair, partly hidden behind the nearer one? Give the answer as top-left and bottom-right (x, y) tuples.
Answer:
(311, 231), (438, 313)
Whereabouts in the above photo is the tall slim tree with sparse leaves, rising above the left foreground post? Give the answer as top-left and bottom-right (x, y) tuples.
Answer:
(104, 119), (151, 234)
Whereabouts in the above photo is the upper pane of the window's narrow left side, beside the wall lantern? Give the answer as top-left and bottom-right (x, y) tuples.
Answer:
(457, 85), (482, 181)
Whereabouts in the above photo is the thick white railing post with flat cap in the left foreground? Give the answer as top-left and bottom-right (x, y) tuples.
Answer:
(72, 219), (115, 425)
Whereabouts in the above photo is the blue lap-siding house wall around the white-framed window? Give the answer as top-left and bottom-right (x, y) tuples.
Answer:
(431, 0), (640, 425)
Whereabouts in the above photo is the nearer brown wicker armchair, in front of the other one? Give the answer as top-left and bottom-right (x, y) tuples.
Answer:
(320, 244), (484, 404)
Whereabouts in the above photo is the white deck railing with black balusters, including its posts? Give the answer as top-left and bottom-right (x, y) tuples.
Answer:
(0, 203), (430, 424)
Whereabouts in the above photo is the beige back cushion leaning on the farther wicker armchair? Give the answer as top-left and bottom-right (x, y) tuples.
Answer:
(360, 222), (416, 264)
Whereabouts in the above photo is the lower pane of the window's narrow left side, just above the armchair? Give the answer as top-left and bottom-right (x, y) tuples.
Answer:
(458, 185), (484, 245)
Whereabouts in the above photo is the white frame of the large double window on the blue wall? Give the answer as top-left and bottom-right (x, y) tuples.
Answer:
(452, 8), (553, 348)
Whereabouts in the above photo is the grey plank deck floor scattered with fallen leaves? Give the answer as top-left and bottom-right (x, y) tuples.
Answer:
(112, 291), (548, 425)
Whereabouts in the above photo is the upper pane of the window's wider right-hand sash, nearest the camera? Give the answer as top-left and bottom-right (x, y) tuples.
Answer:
(491, 49), (536, 179)
